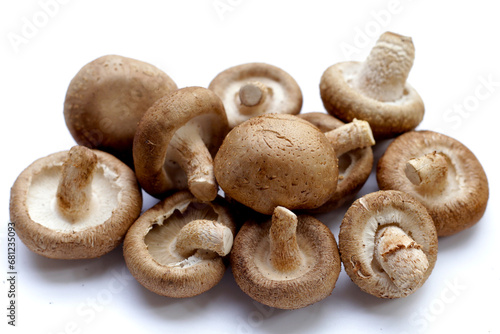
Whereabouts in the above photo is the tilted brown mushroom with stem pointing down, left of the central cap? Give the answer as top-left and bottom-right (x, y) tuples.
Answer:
(133, 87), (228, 201)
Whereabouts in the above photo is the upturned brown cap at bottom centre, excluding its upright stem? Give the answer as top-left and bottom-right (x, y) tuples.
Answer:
(230, 215), (341, 309)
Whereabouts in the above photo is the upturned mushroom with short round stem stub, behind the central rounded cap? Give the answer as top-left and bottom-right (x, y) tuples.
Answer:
(208, 63), (302, 129)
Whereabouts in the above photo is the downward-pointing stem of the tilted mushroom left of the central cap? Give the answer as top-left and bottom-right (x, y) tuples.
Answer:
(170, 124), (218, 202)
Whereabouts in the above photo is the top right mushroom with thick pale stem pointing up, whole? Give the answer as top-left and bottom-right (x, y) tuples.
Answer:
(320, 32), (425, 139)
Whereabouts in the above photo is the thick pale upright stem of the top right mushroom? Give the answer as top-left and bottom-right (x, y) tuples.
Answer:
(354, 32), (415, 102)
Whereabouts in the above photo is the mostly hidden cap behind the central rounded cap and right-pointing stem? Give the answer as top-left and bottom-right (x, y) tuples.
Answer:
(297, 112), (373, 213)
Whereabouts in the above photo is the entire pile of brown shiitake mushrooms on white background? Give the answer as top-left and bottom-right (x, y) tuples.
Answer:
(10, 32), (488, 309)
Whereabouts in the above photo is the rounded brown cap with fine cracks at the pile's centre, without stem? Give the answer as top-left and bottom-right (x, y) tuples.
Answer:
(214, 114), (338, 215)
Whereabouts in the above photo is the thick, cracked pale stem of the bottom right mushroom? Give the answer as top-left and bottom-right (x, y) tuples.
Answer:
(375, 226), (429, 293)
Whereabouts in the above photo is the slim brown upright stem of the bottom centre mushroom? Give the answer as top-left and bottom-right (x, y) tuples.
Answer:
(269, 206), (302, 272)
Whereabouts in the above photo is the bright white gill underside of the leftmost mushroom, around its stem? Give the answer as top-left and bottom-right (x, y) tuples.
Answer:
(26, 164), (120, 232)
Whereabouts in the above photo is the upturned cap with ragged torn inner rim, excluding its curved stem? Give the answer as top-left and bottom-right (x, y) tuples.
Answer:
(123, 191), (235, 298)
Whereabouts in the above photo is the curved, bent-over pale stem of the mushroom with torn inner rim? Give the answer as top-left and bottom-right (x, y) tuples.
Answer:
(175, 219), (233, 258)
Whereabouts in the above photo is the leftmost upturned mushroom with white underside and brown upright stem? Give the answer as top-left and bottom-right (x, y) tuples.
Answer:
(10, 146), (142, 259)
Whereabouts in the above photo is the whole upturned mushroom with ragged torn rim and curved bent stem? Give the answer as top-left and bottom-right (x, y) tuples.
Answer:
(123, 191), (235, 298)
